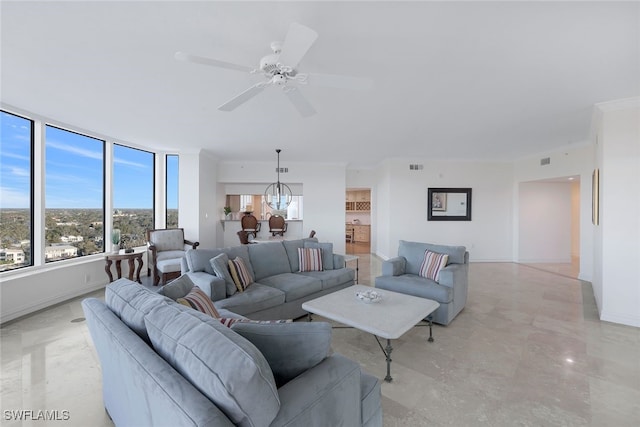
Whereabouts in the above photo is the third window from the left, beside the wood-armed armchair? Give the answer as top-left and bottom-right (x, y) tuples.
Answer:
(111, 144), (155, 248)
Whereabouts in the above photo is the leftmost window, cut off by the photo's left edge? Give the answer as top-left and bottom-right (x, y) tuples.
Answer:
(0, 111), (33, 271)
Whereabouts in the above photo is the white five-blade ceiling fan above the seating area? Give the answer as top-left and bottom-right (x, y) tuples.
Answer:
(175, 23), (373, 117)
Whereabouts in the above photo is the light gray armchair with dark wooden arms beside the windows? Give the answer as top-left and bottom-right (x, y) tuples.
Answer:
(147, 228), (200, 286)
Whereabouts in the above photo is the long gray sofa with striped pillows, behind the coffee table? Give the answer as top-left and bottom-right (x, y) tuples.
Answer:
(182, 238), (355, 320)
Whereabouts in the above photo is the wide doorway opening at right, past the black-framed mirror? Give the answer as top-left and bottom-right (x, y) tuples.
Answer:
(518, 176), (580, 278)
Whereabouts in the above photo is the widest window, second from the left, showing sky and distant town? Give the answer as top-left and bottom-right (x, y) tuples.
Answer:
(45, 125), (105, 262)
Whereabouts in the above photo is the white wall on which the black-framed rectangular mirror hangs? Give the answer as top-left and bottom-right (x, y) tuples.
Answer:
(374, 159), (513, 261)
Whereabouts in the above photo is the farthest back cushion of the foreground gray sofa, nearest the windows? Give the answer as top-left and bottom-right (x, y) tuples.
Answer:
(105, 278), (172, 342)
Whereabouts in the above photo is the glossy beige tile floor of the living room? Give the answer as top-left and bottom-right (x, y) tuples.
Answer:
(0, 253), (640, 427)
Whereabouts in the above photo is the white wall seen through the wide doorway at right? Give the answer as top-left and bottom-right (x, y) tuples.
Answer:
(518, 181), (572, 262)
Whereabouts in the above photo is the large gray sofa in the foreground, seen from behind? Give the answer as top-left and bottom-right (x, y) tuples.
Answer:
(82, 279), (382, 427)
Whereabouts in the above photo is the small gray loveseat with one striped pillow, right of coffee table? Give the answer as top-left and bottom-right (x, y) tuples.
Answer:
(375, 240), (469, 325)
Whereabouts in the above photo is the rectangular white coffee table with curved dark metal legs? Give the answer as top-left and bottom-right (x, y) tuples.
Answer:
(302, 285), (440, 382)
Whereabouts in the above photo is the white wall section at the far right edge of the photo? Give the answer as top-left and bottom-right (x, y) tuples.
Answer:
(593, 98), (640, 326)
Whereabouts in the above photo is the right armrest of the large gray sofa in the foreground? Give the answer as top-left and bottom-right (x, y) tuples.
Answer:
(271, 353), (361, 427)
